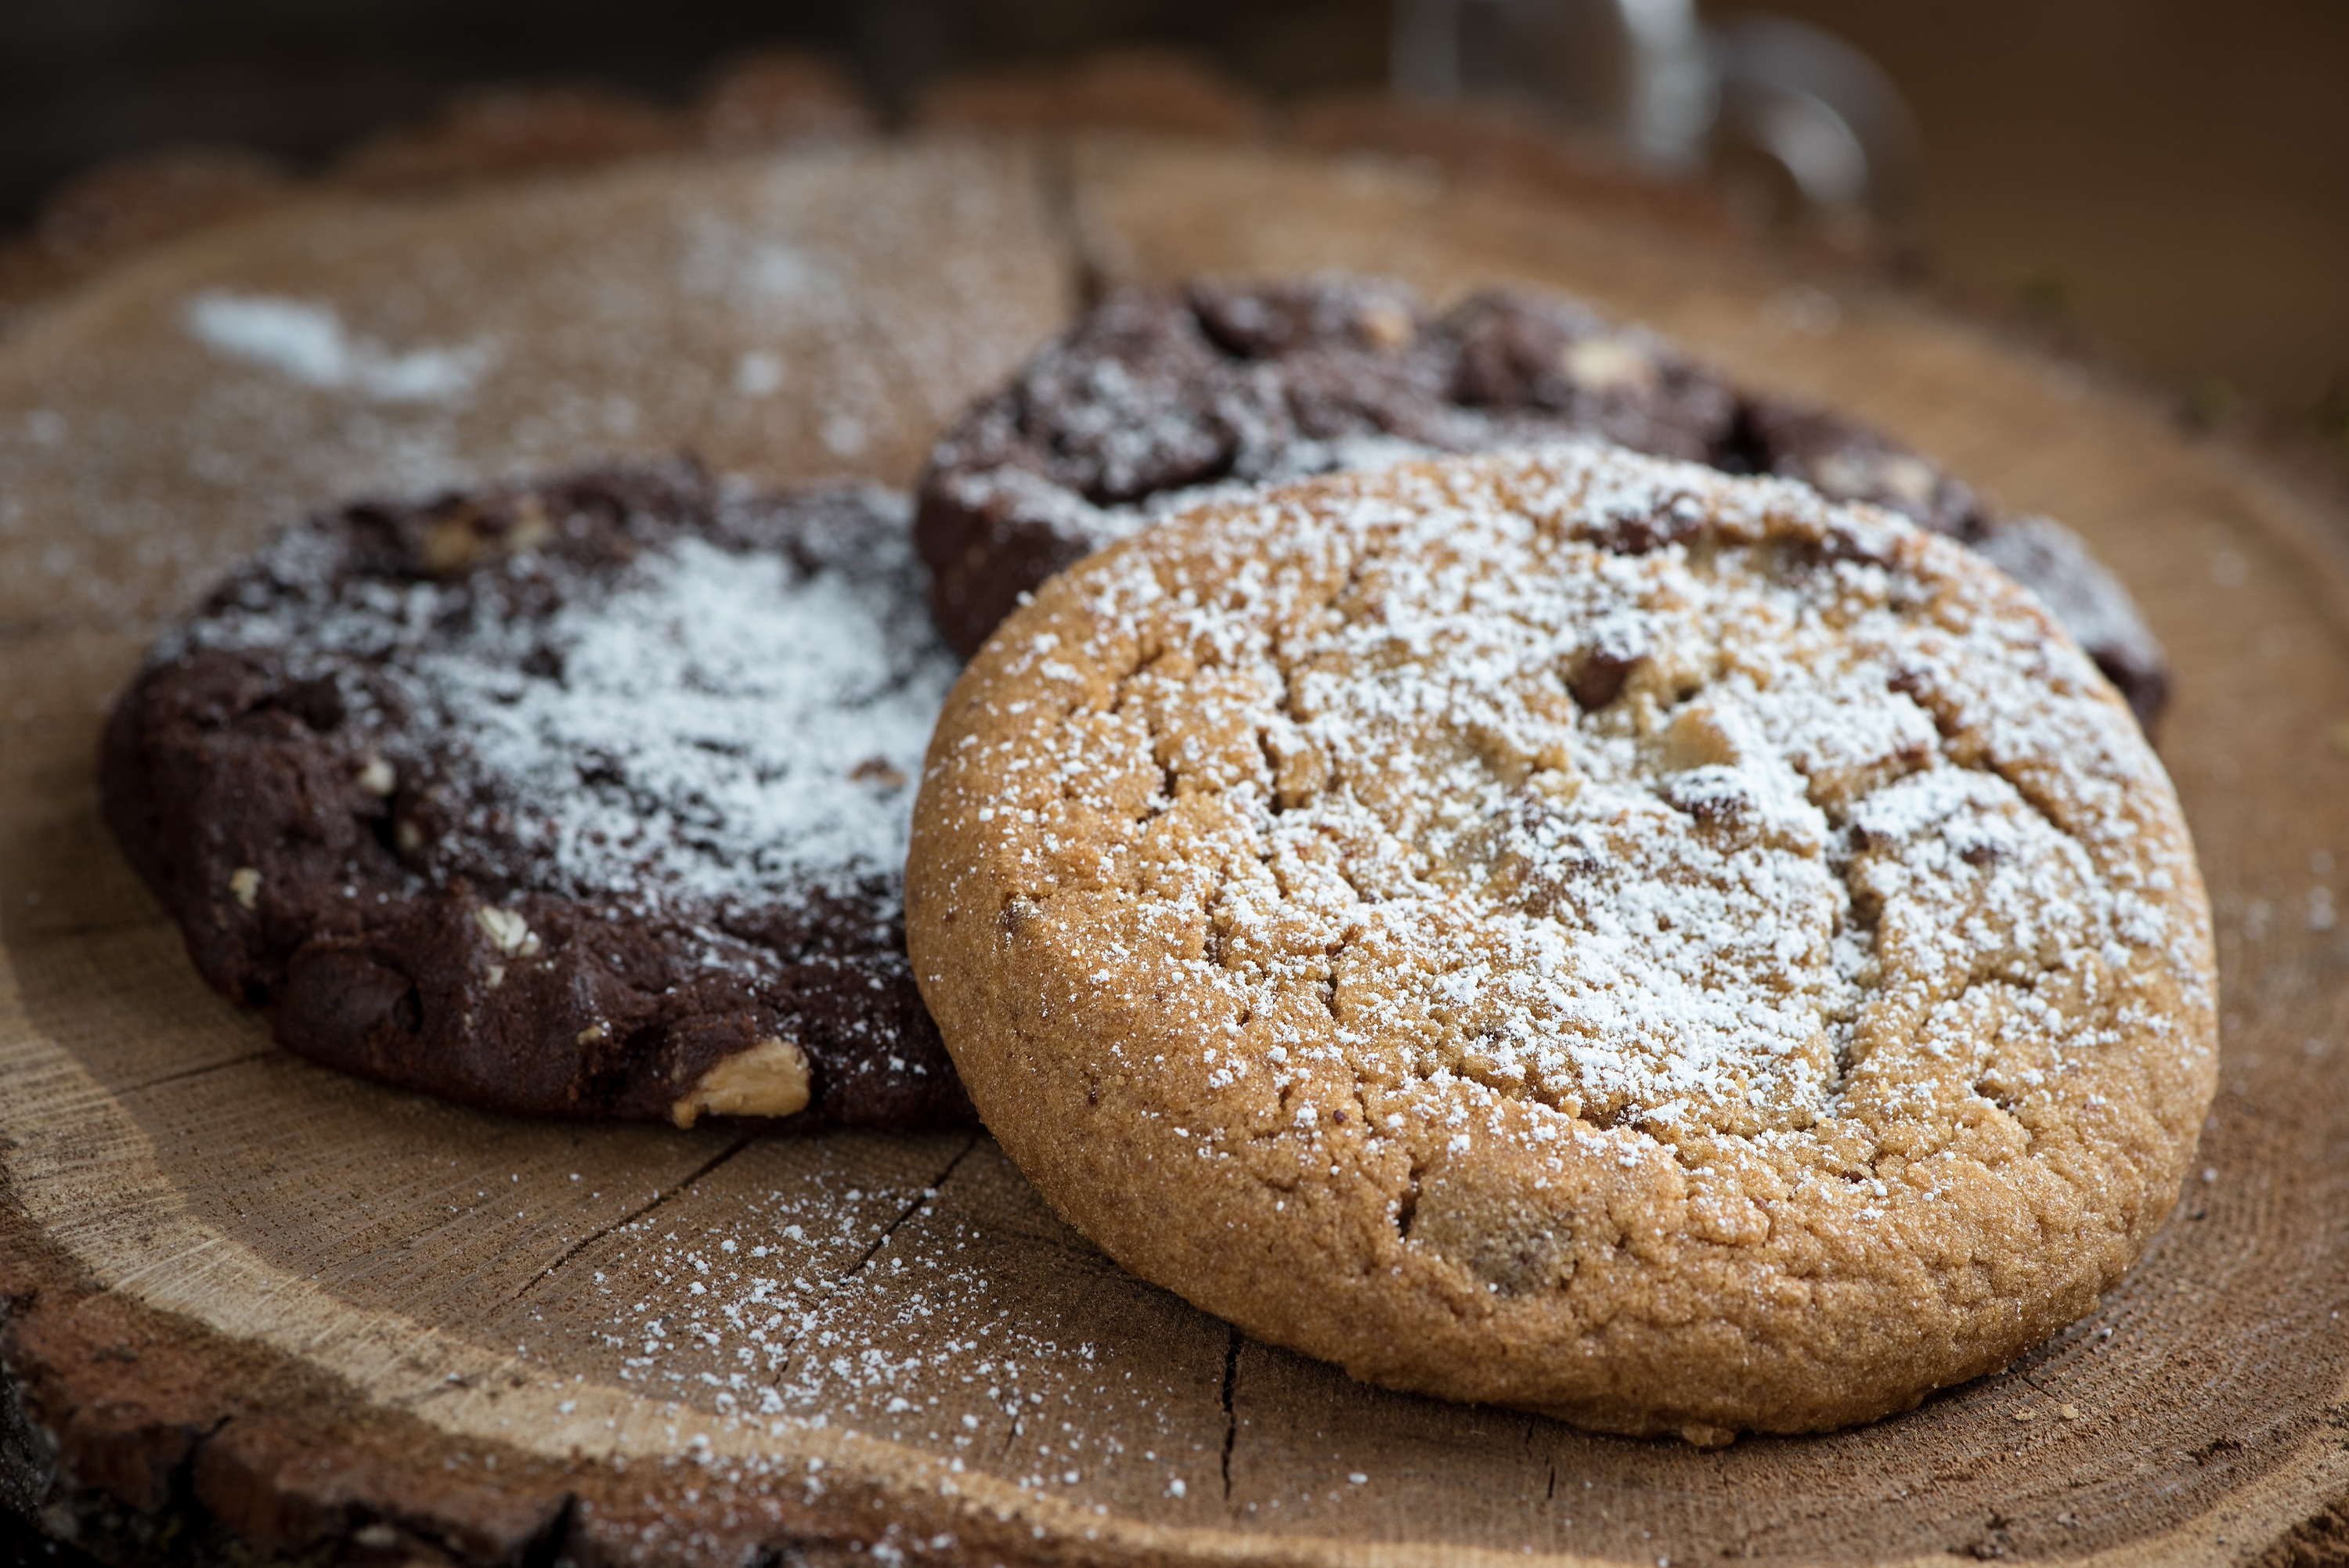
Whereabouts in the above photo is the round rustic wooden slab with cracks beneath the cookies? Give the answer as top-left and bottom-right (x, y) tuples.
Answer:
(0, 139), (2349, 1563)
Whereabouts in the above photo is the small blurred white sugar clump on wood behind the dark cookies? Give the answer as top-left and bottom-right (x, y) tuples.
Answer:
(186, 289), (489, 404)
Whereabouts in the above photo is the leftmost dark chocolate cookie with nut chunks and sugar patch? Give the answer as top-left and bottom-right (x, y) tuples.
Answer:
(101, 465), (970, 1126)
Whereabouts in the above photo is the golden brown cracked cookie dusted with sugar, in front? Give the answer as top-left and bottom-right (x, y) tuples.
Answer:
(907, 446), (2215, 1441)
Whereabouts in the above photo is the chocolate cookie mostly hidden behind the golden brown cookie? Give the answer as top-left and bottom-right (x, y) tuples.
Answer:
(914, 275), (2168, 728)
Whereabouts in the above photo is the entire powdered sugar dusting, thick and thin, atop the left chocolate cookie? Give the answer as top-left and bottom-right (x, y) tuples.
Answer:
(183, 493), (956, 920)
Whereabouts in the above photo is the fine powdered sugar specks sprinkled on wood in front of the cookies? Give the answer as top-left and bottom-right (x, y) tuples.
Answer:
(514, 1134), (1226, 1495)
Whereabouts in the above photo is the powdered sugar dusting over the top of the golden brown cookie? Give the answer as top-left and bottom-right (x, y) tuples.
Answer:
(944, 449), (2208, 1152)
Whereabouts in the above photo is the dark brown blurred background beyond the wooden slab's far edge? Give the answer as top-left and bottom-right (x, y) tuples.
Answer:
(0, 0), (2349, 453)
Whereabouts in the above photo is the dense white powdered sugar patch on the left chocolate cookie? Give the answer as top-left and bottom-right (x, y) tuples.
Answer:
(428, 538), (956, 899)
